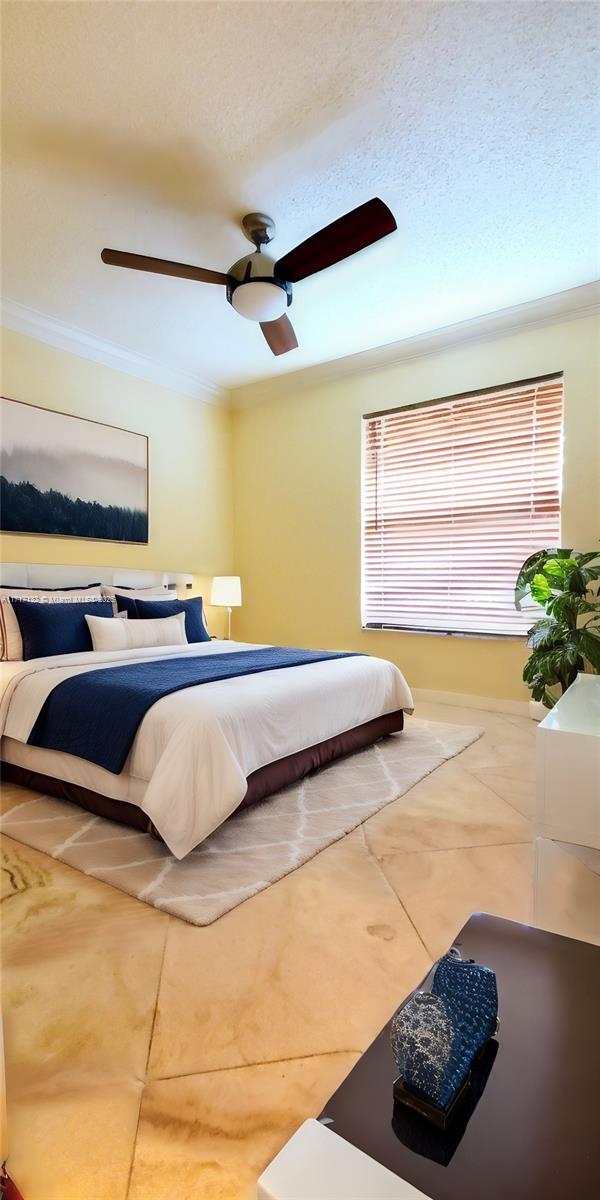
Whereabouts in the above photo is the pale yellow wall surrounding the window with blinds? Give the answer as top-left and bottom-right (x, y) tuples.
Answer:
(234, 317), (600, 700)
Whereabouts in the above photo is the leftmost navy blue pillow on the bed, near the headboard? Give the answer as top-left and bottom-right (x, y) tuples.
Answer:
(11, 599), (113, 659)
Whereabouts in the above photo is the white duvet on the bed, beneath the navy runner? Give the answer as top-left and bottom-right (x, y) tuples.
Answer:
(0, 641), (413, 858)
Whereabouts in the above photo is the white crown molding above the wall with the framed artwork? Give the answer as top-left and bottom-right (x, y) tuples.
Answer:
(1, 298), (227, 404)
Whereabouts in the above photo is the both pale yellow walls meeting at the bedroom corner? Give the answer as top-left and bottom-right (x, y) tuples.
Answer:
(1, 317), (600, 700)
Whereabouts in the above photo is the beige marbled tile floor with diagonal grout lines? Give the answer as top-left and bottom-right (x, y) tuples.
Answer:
(2, 704), (595, 1200)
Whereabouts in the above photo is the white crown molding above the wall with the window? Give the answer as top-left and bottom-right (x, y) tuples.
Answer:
(229, 280), (600, 408)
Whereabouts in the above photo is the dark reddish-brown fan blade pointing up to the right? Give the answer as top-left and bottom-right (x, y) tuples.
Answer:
(275, 198), (397, 283)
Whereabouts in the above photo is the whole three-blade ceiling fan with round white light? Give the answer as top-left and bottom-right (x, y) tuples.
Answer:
(101, 198), (396, 354)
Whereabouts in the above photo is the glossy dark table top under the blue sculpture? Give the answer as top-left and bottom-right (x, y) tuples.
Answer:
(322, 913), (600, 1200)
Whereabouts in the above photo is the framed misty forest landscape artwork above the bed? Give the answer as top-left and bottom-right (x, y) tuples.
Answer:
(0, 397), (148, 542)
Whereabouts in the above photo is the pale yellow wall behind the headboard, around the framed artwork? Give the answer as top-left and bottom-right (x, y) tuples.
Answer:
(1, 329), (233, 634)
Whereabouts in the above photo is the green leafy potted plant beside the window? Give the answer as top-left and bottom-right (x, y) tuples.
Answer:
(515, 550), (600, 708)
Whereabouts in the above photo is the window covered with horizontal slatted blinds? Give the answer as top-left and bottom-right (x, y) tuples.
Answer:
(362, 374), (563, 636)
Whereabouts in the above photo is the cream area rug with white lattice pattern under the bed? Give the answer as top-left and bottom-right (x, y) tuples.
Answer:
(1, 718), (481, 925)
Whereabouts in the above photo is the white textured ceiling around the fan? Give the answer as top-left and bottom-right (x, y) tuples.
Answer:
(2, 0), (600, 386)
